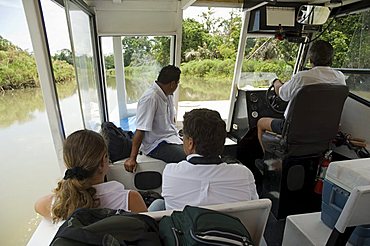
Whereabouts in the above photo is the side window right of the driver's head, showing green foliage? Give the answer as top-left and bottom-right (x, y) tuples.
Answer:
(310, 10), (370, 105)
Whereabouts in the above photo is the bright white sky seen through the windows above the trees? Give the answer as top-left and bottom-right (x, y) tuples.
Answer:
(0, 0), (237, 54)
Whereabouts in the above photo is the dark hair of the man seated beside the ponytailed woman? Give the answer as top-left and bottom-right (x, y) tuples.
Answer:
(183, 108), (226, 157)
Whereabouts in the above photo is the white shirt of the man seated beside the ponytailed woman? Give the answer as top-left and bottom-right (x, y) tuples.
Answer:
(162, 155), (258, 210)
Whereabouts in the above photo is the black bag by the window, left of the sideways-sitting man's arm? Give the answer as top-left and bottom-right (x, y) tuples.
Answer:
(101, 122), (133, 162)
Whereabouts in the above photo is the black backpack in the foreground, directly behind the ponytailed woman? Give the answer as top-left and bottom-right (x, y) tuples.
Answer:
(50, 208), (161, 246)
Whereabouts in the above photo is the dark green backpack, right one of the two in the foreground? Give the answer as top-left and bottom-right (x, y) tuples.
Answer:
(159, 205), (254, 246)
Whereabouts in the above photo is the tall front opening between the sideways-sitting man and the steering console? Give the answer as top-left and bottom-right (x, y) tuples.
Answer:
(177, 7), (242, 121)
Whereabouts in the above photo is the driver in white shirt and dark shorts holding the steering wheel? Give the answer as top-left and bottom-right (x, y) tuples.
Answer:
(257, 40), (346, 152)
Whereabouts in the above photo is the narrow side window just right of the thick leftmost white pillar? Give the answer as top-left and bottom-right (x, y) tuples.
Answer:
(41, 0), (84, 136)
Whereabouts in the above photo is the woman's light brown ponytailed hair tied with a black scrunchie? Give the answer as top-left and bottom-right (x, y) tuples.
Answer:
(52, 130), (107, 222)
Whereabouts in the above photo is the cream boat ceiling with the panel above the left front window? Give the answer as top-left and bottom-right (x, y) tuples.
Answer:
(84, 0), (370, 36)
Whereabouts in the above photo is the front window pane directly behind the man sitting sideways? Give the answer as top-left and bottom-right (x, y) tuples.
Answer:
(101, 36), (171, 130)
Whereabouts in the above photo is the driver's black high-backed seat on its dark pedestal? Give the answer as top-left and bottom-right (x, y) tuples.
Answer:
(256, 84), (348, 219)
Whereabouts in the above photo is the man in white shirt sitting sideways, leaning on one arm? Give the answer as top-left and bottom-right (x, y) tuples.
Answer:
(124, 65), (186, 172)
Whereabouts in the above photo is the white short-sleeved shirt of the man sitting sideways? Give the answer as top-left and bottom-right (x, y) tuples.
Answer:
(136, 82), (182, 155)
